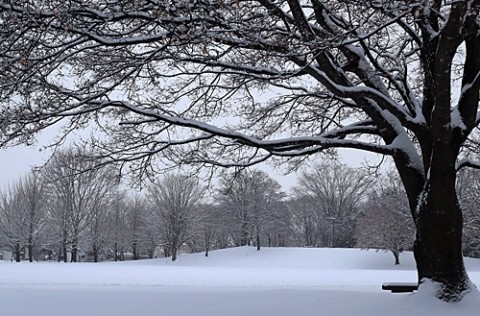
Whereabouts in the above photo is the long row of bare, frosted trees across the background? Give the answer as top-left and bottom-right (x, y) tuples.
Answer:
(0, 148), (480, 264)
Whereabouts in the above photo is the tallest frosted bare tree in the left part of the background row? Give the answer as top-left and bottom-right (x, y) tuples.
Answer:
(43, 148), (116, 262)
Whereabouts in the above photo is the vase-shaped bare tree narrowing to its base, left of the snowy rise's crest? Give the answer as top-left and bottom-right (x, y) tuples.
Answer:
(150, 174), (204, 261)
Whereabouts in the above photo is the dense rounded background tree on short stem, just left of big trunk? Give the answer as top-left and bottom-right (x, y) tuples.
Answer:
(355, 172), (415, 265)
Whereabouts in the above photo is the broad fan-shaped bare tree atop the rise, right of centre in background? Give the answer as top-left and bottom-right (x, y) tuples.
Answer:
(294, 163), (371, 247)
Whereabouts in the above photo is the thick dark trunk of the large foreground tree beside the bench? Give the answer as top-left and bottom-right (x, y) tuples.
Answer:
(395, 127), (472, 302)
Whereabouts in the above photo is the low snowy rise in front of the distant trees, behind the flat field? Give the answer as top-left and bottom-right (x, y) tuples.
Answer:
(138, 247), (480, 271)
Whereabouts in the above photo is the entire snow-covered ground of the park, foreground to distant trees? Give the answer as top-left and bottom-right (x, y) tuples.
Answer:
(0, 247), (480, 316)
